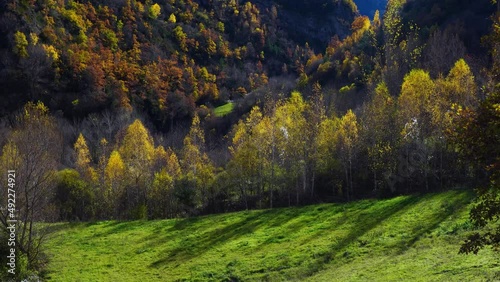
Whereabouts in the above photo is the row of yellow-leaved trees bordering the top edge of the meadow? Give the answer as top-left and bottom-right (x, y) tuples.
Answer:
(1, 56), (478, 225)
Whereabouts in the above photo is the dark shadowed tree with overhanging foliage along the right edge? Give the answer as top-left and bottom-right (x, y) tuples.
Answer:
(458, 14), (500, 254)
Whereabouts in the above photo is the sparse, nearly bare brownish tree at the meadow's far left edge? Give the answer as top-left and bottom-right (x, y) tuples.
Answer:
(0, 102), (62, 269)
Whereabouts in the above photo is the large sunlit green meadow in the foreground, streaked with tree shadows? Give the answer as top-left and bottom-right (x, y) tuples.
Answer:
(45, 191), (500, 281)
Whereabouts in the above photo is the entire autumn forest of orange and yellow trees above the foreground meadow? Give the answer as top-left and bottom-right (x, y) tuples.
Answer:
(0, 0), (500, 281)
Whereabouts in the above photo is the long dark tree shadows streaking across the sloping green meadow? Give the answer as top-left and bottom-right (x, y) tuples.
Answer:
(43, 189), (471, 279)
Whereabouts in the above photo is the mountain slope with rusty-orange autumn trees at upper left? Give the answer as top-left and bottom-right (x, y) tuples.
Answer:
(0, 0), (355, 126)
